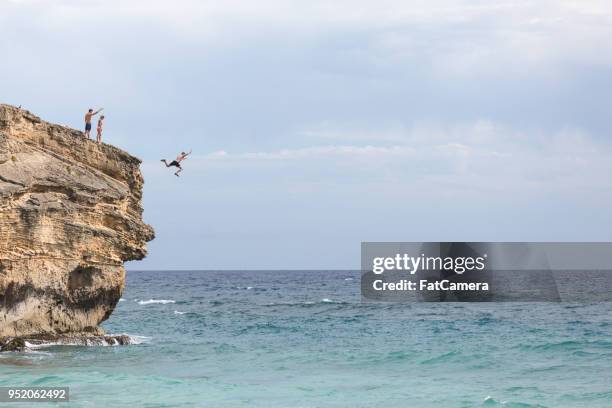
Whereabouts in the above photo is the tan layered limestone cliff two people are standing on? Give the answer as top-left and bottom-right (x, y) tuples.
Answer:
(0, 105), (154, 338)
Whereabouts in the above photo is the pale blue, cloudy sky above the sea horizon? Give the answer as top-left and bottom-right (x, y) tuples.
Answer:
(0, 0), (612, 270)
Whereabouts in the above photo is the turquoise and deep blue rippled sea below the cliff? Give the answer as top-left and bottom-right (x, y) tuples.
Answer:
(0, 271), (612, 408)
